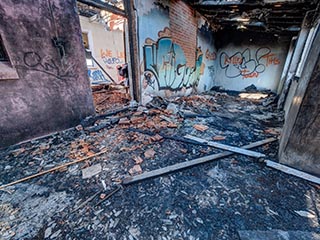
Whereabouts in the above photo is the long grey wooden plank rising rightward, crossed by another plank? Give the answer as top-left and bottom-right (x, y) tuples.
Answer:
(122, 138), (277, 185)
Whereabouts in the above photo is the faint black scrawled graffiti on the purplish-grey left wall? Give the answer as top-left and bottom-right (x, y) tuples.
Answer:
(18, 51), (76, 79)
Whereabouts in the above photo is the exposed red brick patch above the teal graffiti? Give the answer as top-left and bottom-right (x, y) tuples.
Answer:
(169, 0), (198, 67)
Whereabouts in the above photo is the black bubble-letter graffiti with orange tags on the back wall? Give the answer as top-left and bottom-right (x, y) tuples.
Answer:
(220, 47), (280, 79)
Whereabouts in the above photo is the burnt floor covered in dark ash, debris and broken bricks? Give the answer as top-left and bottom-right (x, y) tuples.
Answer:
(0, 92), (320, 240)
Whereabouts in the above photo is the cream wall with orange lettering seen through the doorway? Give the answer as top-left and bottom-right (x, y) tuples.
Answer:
(80, 14), (125, 83)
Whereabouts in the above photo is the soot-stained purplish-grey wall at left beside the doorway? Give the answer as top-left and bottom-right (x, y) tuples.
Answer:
(0, 0), (94, 147)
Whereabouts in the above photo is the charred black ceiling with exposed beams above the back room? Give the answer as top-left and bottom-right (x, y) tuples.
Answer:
(186, 0), (320, 34)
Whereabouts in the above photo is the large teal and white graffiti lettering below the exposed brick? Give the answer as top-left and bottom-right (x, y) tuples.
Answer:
(143, 28), (203, 91)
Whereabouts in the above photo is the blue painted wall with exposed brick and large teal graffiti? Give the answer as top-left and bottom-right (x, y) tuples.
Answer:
(137, 0), (216, 104)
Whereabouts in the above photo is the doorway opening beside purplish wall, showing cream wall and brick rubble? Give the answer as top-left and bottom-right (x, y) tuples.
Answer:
(77, 1), (131, 114)
